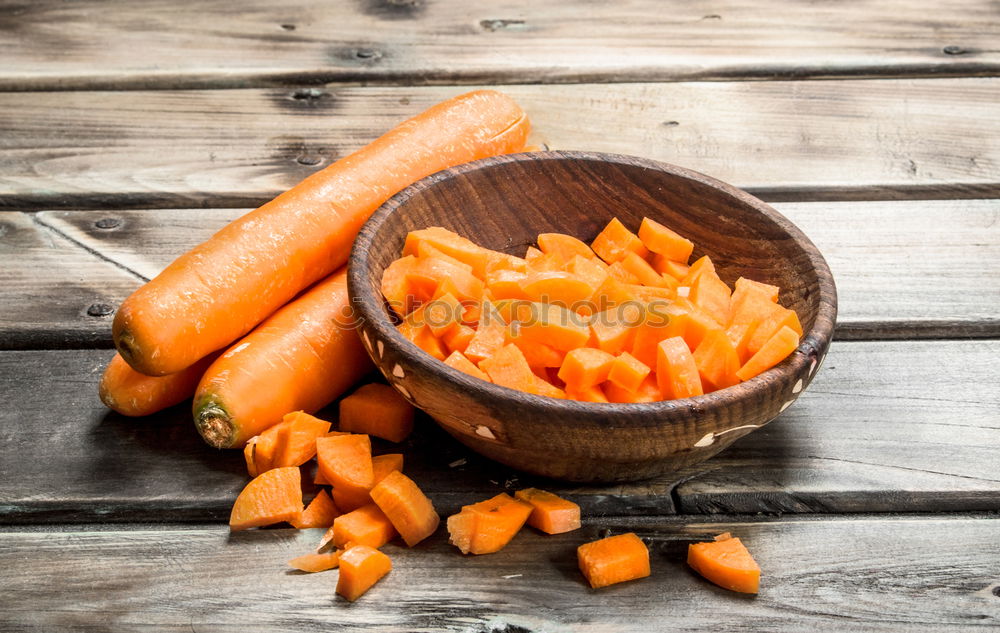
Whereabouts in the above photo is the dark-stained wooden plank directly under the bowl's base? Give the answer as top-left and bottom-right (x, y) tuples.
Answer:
(0, 340), (1000, 523)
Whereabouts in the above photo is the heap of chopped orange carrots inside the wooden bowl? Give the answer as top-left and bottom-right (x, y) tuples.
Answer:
(382, 218), (802, 402)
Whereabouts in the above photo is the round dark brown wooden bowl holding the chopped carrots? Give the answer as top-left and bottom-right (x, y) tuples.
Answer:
(348, 152), (837, 482)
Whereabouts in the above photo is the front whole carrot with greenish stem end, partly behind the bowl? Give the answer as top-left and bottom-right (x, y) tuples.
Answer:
(194, 269), (372, 448)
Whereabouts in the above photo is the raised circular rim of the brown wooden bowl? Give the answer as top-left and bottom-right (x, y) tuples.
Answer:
(348, 151), (837, 430)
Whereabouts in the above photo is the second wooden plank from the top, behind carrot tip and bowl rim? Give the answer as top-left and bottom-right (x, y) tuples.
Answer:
(0, 78), (1000, 209)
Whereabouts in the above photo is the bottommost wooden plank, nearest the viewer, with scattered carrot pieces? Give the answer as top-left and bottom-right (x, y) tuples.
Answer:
(0, 516), (1000, 633)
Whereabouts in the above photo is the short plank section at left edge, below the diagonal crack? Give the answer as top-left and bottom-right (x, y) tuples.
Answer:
(0, 212), (141, 349)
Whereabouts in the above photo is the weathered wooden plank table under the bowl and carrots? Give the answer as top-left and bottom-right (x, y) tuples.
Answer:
(0, 0), (1000, 633)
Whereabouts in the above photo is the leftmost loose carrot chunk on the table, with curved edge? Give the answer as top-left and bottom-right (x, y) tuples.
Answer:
(229, 466), (302, 532)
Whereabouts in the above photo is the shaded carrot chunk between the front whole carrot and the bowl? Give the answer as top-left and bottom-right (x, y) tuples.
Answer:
(340, 383), (414, 442)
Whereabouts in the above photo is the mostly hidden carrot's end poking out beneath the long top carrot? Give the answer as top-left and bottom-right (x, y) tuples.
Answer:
(98, 354), (216, 417)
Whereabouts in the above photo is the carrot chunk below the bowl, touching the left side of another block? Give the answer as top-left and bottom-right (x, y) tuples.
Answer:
(448, 492), (533, 554)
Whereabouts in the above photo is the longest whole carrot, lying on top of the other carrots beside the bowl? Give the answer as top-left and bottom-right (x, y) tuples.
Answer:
(113, 90), (530, 376)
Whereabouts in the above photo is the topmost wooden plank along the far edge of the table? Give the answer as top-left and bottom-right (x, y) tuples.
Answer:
(0, 0), (1000, 90)
